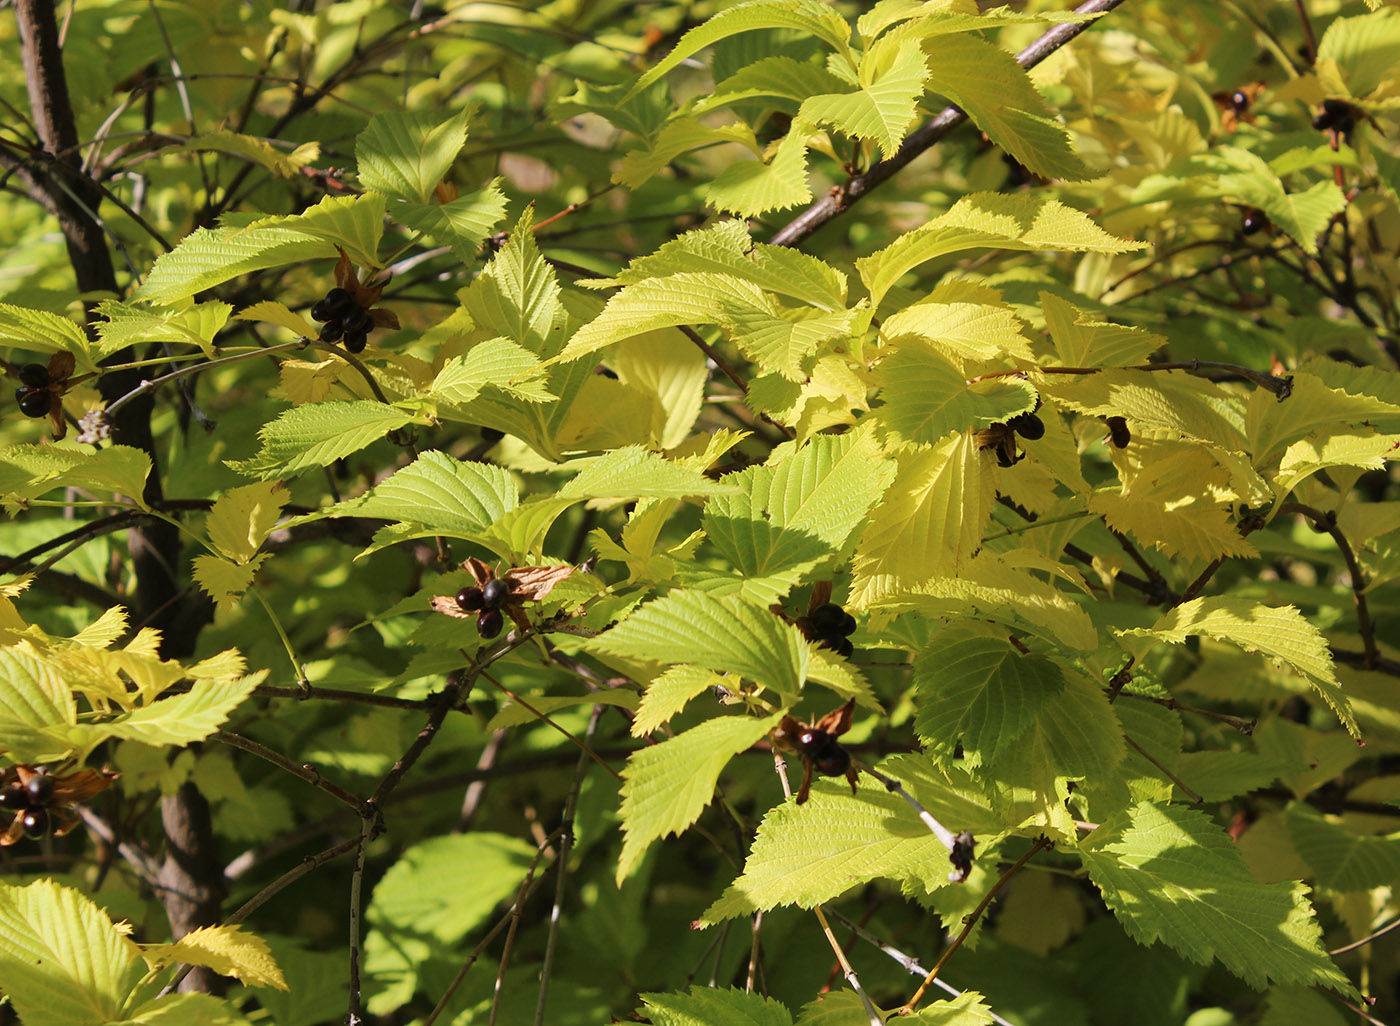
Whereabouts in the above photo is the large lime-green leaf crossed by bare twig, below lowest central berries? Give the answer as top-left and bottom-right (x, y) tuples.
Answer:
(699, 756), (1001, 927)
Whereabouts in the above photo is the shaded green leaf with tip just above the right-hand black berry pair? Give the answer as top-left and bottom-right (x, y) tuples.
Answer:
(878, 339), (1036, 445)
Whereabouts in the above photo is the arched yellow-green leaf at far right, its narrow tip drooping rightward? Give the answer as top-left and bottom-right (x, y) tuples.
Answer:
(1117, 595), (1359, 738)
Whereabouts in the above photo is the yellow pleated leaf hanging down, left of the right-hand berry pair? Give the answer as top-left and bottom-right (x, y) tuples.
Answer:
(851, 434), (995, 605)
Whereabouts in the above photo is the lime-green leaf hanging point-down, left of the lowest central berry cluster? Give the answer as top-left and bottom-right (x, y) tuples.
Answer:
(617, 714), (781, 886)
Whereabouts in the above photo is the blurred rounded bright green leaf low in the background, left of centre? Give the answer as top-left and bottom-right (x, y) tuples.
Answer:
(365, 830), (535, 945)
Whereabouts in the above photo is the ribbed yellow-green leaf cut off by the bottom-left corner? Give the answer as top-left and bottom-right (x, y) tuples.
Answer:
(0, 880), (143, 1026)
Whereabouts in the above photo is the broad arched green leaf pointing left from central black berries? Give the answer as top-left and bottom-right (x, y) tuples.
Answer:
(587, 591), (806, 698)
